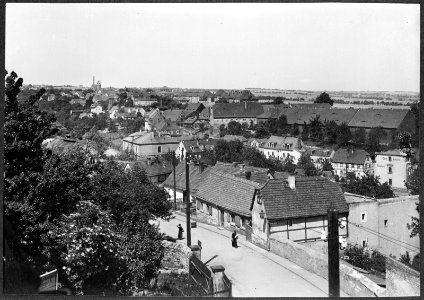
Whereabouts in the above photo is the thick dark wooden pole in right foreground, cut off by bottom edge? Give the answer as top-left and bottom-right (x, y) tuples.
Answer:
(327, 208), (340, 297)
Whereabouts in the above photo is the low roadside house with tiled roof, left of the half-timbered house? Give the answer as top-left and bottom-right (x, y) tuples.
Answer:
(194, 167), (260, 230)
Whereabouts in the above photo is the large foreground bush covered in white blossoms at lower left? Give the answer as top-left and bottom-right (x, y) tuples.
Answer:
(53, 201), (126, 294)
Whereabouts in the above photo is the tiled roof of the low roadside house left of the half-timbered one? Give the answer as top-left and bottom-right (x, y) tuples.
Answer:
(195, 169), (259, 217)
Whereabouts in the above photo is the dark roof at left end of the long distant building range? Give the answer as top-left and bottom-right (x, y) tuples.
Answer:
(213, 102), (264, 118)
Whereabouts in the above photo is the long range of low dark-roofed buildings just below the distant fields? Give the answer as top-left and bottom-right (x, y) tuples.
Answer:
(211, 102), (415, 137)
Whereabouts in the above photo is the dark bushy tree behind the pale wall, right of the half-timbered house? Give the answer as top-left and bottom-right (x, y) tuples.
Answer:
(342, 173), (394, 199)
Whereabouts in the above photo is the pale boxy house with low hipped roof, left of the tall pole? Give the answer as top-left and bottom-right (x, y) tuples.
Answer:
(122, 131), (179, 157)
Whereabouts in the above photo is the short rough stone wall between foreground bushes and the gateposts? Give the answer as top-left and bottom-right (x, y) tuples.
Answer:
(161, 241), (192, 273)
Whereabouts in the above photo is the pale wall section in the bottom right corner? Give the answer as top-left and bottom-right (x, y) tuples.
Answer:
(386, 257), (420, 297)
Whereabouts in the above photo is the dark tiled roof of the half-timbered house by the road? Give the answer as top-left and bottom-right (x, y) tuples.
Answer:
(261, 176), (349, 220)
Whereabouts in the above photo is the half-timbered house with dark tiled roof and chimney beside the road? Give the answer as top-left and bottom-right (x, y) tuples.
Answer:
(248, 176), (349, 249)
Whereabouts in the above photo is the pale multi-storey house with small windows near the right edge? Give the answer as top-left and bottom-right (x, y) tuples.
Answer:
(374, 149), (418, 189)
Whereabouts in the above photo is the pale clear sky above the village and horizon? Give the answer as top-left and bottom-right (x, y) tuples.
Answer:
(5, 3), (420, 92)
